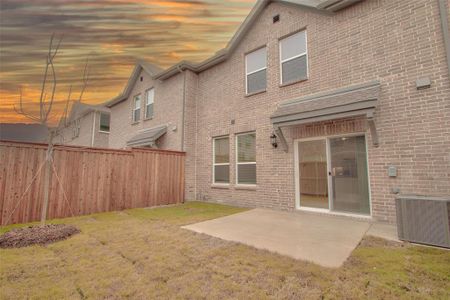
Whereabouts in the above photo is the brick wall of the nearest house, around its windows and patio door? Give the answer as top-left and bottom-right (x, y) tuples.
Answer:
(186, 0), (450, 222)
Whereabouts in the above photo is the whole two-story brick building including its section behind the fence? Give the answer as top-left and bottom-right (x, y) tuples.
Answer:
(107, 0), (450, 223)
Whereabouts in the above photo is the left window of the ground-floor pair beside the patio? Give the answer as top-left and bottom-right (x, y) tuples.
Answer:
(213, 136), (230, 184)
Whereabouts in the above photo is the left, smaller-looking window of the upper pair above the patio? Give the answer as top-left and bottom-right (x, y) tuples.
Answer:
(245, 47), (267, 95)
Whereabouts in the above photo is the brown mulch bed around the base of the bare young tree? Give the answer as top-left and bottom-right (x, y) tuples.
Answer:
(0, 224), (80, 248)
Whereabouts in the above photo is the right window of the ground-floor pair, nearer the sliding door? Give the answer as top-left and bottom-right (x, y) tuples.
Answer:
(236, 132), (256, 184)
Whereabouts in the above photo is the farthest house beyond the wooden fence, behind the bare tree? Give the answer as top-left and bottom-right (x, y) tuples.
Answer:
(56, 102), (110, 148)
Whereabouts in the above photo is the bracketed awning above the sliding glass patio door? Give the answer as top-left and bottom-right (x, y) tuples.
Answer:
(270, 81), (380, 151)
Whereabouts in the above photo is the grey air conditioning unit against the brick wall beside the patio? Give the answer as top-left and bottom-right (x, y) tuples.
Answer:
(395, 195), (450, 248)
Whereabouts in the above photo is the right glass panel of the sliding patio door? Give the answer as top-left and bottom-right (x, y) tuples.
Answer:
(329, 136), (370, 215)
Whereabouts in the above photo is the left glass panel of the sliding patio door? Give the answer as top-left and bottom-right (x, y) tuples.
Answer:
(298, 139), (329, 209)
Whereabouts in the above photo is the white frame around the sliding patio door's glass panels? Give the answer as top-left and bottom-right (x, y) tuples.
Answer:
(294, 132), (372, 219)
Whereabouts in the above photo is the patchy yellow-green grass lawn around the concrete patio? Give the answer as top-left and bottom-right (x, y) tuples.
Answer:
(0, 202), (450, 299)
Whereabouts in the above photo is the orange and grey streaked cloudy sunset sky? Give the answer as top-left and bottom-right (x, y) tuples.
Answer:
(0, 0), (255, 122)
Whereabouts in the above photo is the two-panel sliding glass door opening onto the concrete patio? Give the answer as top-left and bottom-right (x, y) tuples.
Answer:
(296, 136), (370, 215)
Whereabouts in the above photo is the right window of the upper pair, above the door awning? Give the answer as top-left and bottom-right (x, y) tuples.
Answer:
(280, 30), (308, 84)
